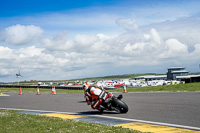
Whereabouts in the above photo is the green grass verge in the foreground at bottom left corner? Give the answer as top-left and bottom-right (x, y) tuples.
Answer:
(0, 110), (139, 133)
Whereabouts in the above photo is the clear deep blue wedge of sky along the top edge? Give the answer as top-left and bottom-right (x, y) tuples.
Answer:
(0, 0), (164, 17)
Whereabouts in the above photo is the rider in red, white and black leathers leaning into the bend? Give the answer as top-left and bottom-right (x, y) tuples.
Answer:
(83, 83), (112, 110)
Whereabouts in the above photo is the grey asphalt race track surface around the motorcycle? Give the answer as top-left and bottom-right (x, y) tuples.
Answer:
(0, 92), (200, 128)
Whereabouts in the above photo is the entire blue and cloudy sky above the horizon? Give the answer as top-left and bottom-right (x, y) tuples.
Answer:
(0, 0), (200, 82)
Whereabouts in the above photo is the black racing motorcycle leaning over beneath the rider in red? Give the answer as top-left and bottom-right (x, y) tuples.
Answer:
(99, 94), (128, 113)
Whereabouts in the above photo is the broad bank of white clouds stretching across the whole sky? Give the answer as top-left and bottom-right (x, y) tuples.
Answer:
(0, 13), (200, 80)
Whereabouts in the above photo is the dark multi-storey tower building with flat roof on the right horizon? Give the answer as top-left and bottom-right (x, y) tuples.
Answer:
(167, 67), (189, 80)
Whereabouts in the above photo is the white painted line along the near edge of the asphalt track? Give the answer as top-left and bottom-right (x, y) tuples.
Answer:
(0, 108), (200, 131)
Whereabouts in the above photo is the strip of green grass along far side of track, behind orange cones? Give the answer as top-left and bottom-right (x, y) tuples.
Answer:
(0, 82), (200, 93)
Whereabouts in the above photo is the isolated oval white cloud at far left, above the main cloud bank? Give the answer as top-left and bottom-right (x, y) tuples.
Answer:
(1, 24), (43, 45)
